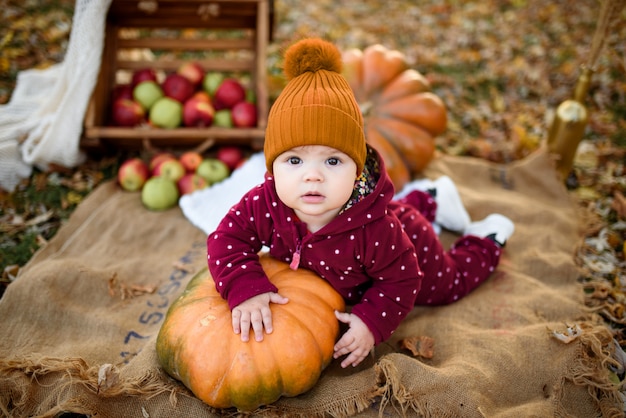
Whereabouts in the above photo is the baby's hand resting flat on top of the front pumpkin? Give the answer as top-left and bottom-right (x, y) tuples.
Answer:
(231, 292), (289, 342)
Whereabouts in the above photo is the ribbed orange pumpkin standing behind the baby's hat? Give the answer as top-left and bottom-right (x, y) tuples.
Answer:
(342, 44), (447, 190)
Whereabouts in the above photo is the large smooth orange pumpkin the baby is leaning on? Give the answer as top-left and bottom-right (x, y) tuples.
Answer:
(156, 255), (345, 411)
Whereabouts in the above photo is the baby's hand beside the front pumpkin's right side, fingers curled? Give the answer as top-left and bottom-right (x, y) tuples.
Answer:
(333, 311), (375, 368)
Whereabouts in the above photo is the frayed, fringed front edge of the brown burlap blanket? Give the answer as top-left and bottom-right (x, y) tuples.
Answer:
(0, 322), (624, 418)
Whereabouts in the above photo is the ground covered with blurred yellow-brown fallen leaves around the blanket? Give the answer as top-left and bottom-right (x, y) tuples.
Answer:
(0, 0), (626, 370)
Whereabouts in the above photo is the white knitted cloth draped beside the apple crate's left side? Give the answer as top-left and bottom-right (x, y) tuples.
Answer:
(0, 0), (111, 191)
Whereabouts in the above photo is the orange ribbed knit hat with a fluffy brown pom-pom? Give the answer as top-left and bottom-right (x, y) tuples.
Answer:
(264, 38), (367, 175)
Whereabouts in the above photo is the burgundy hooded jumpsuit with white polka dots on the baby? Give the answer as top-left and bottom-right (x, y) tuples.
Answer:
(207, 150), (501, 344)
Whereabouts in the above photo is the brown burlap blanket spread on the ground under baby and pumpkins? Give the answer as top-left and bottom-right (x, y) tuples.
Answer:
(0, 151), (621, 418)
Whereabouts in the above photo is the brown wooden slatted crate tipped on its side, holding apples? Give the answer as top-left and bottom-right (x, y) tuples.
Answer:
(81, 0), (273, 149)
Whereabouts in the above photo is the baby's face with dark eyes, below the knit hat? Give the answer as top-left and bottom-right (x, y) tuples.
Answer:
(273, 145), (356, 232)
